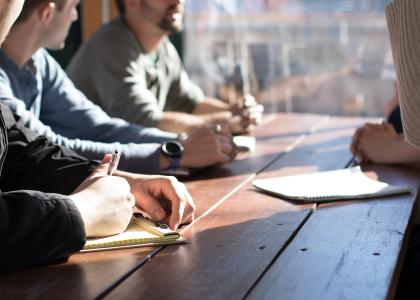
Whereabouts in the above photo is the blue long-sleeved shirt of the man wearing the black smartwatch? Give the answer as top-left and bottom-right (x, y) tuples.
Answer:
(0, 49), (176, 173)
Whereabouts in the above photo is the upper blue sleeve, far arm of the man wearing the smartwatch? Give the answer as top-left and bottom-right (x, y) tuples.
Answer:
(38, 50), (174, 143)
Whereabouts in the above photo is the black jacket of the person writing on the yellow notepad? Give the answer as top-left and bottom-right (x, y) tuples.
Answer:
(0, 104), (97, 271)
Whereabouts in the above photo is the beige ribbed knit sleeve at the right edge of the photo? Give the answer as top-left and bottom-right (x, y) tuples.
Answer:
(386, 0), (420, 148)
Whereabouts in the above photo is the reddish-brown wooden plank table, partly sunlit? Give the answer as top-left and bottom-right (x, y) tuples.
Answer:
(0, 114), (419, 300)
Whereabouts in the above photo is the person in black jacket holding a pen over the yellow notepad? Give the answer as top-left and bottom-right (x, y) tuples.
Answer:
(0, 0), (194, 272)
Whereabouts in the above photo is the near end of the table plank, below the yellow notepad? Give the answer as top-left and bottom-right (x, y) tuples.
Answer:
(0, 247), (158, 299)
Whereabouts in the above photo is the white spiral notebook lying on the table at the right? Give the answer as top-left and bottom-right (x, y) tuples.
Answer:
(253, 166), (410, 202)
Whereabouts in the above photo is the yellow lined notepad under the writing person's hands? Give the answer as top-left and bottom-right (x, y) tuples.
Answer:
(82, 213), (185, 252)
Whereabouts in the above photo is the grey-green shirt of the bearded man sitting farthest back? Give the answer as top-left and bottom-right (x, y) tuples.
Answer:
(67, 18), (204, 127)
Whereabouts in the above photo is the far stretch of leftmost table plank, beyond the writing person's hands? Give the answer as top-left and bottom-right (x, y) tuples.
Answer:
(186, 114), (325, 217)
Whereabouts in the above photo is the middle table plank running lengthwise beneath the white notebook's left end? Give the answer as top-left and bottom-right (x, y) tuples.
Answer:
(107, 119), (370, 299)
